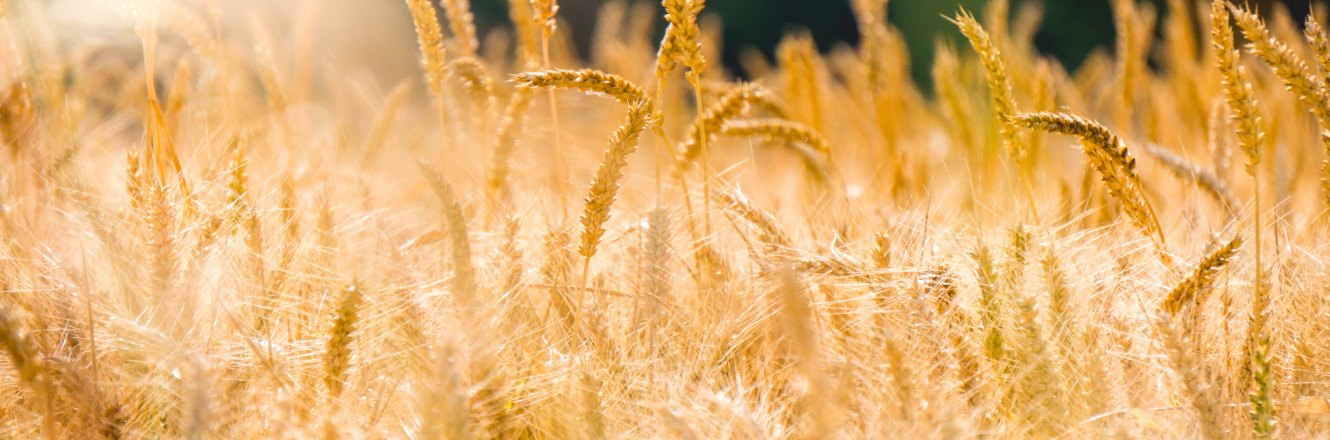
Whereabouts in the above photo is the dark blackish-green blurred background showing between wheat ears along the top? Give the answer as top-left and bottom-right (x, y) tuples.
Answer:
(472, 0), (1310, 86)
